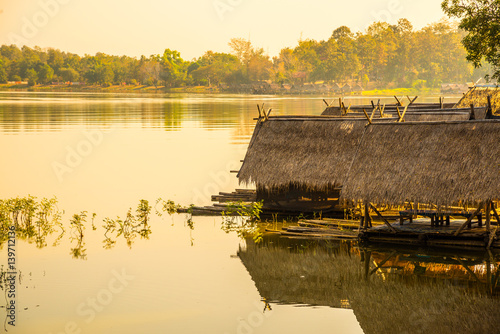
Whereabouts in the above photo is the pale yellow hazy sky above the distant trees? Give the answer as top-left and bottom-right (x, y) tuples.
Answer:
(0, 0), (444, 60)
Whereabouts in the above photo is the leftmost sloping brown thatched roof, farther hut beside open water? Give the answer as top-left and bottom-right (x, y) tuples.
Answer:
(238, 116), (376, 190)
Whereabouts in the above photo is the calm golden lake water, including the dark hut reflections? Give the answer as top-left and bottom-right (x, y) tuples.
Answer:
(0, 93), (498, 333)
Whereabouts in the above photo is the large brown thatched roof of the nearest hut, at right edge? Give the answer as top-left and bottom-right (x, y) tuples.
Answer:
(342, 120), (500, 204)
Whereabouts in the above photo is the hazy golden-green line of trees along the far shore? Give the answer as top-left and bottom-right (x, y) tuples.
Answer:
(0, 19), (491, 88)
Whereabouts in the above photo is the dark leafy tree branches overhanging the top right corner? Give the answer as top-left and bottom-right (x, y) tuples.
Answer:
(441, 0), (500, 79)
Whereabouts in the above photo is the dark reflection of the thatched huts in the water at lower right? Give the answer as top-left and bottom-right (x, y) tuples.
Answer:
(238, 236), (500, 333)
